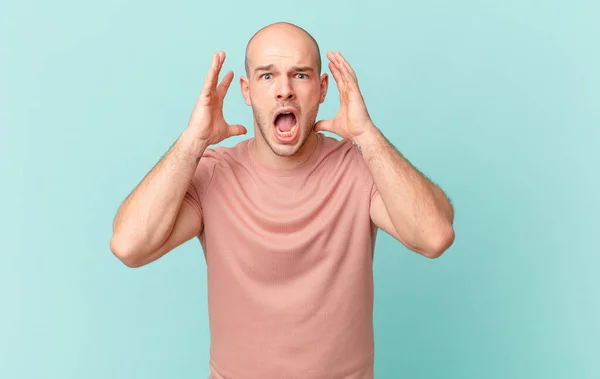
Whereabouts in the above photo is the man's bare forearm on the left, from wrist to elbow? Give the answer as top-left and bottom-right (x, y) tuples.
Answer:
(111, 130), (207, 255)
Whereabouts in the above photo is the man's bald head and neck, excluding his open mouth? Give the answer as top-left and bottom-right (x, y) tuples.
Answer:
(240, 24), (329, 168)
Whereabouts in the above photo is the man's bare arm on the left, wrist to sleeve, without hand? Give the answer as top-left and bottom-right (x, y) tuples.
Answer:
(110, 129), (208, 267)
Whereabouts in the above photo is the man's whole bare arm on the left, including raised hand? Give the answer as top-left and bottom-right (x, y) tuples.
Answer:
(110, 51), (247, 267)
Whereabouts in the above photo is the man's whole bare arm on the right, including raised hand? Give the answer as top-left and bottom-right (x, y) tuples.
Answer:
(314, 51), (454, 258)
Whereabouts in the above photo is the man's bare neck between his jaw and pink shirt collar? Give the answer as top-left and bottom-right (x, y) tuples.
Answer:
(251, 131), (318, 170)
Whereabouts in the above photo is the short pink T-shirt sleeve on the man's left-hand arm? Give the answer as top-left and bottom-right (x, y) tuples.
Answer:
(183, 149), (219, 224)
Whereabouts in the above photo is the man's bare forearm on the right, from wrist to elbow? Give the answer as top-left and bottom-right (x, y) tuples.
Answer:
(355, 125), (454, 254)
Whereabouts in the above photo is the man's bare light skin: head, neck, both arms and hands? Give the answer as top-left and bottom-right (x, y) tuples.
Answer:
(110, 24), (454, 267)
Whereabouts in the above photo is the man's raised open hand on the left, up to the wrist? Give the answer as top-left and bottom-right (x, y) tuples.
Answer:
(188, 51), (248, 145)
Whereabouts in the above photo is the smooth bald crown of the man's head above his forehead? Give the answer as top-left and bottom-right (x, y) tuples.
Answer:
(245, 22), (321, 76)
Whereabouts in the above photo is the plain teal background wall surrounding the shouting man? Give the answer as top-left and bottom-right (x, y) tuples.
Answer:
(0, 0), (600, 379)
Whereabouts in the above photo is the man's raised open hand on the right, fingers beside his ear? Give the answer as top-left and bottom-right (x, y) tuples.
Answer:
(314, 51), (372, 140)
